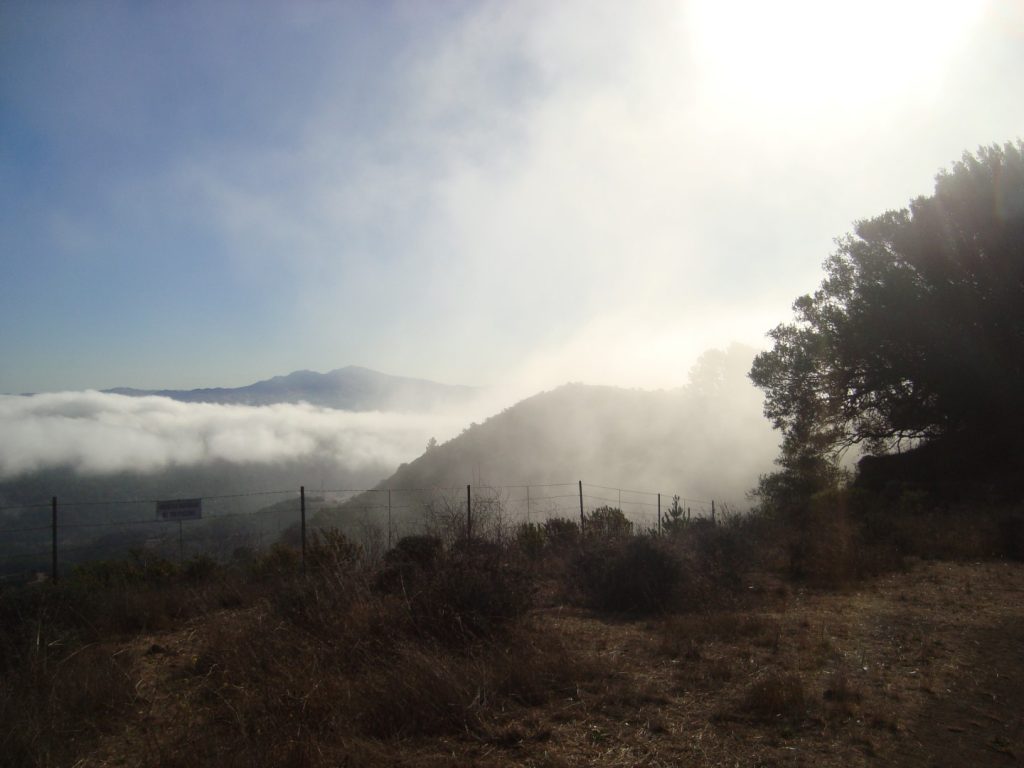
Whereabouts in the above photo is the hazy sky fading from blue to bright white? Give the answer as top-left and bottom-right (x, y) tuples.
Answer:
(0, 0), (1024, 392)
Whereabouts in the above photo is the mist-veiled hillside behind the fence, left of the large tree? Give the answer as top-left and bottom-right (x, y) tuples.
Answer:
(358, 345), (777, 505)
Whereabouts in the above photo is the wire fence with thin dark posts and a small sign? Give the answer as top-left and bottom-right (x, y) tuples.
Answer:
(0, 480), (716, 583)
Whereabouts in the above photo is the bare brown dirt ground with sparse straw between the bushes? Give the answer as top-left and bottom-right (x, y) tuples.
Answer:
(77, 562), (1024, 768)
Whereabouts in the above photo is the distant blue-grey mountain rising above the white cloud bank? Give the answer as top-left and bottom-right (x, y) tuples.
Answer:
(103, 366), (478, 412)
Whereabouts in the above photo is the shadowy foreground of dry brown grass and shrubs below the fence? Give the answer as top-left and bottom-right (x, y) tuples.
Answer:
(0, 507), (1024, 768)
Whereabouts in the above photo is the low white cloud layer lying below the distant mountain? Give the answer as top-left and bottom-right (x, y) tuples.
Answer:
(0, 391), (463, 478)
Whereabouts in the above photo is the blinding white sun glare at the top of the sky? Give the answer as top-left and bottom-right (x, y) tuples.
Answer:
(690, 0), (985, 112)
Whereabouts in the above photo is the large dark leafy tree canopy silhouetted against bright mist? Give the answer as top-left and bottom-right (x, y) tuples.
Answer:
(751, 140), (1024, 473)
